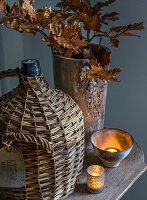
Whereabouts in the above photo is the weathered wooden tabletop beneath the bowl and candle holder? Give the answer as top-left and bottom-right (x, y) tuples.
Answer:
(66, 143), (147, 200)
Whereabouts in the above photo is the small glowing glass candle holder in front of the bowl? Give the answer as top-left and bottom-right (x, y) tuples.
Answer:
(87, 165), (105, 194)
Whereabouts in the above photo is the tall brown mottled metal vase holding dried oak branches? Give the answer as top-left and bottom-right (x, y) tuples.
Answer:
(53, 46), (107, 150)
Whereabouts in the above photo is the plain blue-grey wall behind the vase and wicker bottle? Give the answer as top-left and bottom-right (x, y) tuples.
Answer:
(0, 0), (147, 200)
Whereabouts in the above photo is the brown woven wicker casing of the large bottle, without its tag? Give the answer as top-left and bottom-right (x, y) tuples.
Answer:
(0, 69), (84, 200)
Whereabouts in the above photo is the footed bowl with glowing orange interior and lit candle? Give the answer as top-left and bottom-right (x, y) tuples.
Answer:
(91, 129), (134, 167)
